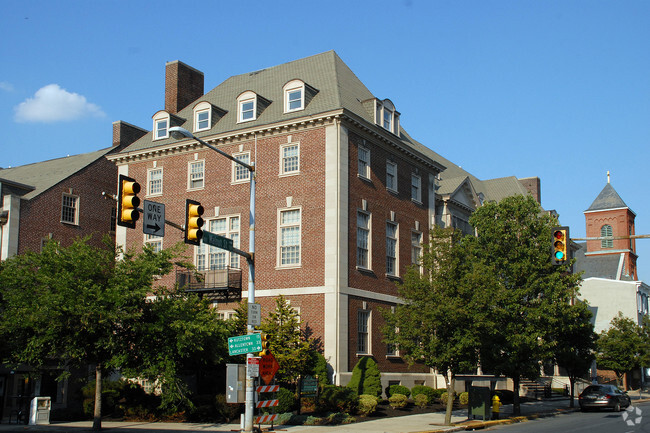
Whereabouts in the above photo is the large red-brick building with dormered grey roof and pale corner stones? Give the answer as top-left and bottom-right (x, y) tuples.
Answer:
(108, 51), (540, 386)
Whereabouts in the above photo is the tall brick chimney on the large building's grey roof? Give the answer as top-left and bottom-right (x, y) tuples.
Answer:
(165, 60), (203, 114)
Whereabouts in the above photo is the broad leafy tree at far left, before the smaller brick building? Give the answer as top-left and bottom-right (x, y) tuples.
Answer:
(0, 238), (225, 429)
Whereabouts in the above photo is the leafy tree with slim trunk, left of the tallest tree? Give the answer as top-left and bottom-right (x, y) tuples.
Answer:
(383, 227), (483, 425)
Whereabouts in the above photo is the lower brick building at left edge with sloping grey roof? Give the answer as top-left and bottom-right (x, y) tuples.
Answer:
(0, 122), (146, 420)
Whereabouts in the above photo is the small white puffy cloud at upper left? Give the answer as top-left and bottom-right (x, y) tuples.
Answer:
(14, 84), (105, 123)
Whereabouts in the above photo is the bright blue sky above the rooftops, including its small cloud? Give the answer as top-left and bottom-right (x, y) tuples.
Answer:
(0, 0), (650, 279)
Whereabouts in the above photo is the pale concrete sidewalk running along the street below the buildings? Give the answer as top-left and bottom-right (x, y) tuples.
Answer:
(0, 391), (650, 433)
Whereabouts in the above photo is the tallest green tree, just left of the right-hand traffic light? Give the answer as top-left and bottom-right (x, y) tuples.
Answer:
(467, 195), (580, 415)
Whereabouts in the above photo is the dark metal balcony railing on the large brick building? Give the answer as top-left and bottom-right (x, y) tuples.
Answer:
(176, 268), (241, 302)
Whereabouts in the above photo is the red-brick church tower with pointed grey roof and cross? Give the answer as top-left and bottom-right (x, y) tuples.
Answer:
(584, 172), (638, 280)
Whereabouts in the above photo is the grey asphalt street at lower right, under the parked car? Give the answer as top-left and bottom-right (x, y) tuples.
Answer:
(488, 402), (650, 433)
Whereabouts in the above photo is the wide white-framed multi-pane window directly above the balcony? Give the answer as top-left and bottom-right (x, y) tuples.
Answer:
(195, 216), (240, 271)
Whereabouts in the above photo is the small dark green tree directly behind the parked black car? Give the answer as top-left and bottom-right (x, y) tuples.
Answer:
(552, 301), (597, 407)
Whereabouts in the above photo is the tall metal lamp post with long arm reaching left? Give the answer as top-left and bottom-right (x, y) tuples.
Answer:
(169, 126), (255, 432)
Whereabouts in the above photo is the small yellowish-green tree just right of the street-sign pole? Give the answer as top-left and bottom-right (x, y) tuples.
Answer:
(261, 296), (314, 385)
